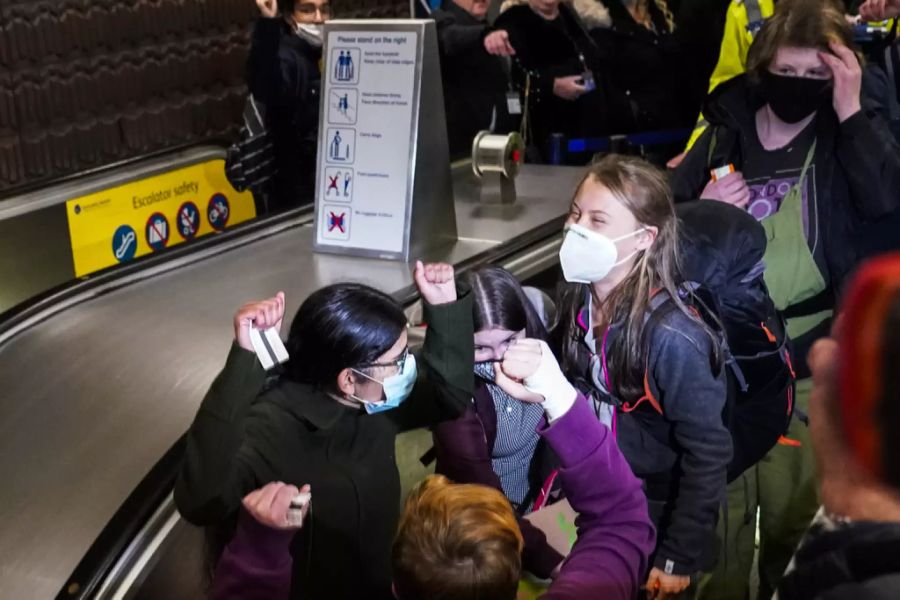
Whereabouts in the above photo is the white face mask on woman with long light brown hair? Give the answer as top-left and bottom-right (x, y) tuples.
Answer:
(559, 225), (645, 283)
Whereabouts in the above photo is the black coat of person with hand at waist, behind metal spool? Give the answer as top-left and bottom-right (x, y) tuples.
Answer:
(494, 4), (609, 160)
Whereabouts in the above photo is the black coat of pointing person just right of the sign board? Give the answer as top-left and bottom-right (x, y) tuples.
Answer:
(431, 0), (512, 159)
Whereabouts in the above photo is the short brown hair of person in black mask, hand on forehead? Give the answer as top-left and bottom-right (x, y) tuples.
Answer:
(747, 0), (861, 83)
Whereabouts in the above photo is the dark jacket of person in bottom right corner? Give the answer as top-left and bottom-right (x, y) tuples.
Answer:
(777, 522), (900, 600)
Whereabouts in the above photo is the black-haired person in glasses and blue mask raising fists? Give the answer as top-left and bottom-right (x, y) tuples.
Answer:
(175, 263), (474, 600)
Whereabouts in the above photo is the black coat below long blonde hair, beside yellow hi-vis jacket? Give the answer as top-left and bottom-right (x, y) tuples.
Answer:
(590, 0), (697, 133)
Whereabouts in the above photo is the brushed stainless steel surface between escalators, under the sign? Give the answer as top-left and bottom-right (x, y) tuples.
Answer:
(0, 167), (581, 598)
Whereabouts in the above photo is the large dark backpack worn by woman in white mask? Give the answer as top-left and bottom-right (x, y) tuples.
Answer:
(645, 200), (796, 482)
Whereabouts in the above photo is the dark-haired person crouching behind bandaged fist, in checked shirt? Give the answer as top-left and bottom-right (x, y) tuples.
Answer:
(434, 267), (563, 578)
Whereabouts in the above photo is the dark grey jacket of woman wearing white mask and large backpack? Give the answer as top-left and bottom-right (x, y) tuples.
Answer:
(569, 296), (731, 575)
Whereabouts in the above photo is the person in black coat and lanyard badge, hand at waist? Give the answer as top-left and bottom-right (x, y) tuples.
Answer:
(494, 0), (623, 162)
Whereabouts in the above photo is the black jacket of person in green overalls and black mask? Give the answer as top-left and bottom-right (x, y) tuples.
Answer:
(672, 76), (900, 377)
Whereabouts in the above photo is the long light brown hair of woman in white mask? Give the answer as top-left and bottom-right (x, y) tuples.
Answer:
(559, 154), (719, 401)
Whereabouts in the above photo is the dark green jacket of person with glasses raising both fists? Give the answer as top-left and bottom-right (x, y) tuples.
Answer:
(175, 292), (474, 600)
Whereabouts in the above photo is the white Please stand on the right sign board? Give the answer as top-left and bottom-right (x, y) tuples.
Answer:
(315, 21), (455, 258)
